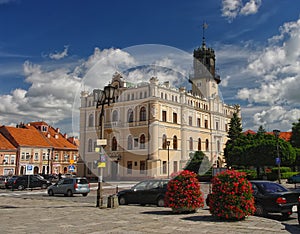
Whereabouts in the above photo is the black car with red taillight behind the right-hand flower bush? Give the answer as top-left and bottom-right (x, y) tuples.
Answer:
(250, 180), (300, 218)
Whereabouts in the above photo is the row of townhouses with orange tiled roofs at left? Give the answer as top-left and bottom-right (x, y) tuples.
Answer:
(0, 122), (78, 175)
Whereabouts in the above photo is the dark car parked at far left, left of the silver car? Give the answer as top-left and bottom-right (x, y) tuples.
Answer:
(6, 175), (51, 190)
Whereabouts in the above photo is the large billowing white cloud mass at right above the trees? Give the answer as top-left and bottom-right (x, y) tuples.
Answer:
(230, 16), (300, 131)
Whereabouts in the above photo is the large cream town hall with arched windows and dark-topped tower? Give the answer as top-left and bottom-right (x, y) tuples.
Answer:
(80, 43), (240, 180)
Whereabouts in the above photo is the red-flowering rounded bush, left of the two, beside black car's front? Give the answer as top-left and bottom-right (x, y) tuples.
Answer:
(165, 170), (204, 213)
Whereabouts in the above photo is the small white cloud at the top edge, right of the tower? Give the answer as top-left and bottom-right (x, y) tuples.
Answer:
(222, 0), (261, 21)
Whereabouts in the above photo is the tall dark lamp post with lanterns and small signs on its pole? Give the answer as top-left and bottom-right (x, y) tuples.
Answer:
(93, 84), (115, 208)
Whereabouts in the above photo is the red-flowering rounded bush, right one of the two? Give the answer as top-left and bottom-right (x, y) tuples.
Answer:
(208, 170), (255, 220)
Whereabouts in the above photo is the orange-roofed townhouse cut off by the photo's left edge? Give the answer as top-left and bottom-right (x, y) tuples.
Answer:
(0, 133), (17, 175)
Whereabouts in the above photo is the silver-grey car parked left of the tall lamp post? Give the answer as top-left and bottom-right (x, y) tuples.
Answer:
(48, 177), (90, 197)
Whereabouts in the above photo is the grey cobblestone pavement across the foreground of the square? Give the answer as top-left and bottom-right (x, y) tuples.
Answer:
(0, 180), (300, 234)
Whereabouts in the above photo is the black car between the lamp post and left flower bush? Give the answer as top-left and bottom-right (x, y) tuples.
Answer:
(117, 179), (169, 207)
